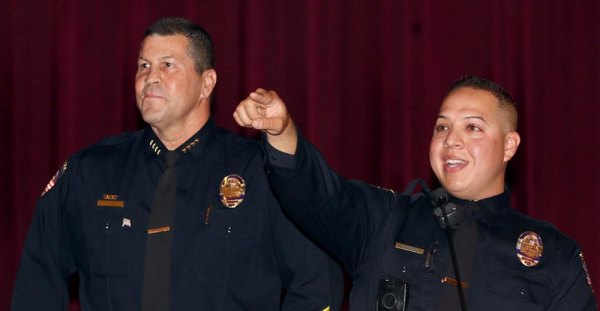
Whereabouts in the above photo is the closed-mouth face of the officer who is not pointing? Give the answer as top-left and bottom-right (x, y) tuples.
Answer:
(135, 35), (216, 130)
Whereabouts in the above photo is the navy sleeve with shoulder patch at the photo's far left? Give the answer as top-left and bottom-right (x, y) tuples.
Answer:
(12, 162), (73, 310)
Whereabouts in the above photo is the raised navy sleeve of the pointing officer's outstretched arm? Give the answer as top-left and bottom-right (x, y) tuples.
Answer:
(263, 138), (395, 274)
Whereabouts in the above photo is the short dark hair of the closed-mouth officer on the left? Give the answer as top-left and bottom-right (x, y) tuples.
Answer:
(144, 17), (215, 74)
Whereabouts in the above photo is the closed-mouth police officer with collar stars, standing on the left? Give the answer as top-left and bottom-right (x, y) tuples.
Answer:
(12, 18), (343, 311)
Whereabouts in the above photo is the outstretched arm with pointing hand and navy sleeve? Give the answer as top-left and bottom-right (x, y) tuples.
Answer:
(234, 89), (395, 273)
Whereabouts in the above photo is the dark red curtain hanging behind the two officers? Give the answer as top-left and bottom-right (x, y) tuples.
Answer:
(0, 0), (600, 310)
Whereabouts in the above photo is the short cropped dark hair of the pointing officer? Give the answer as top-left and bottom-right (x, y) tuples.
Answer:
(446, 75), (519, 131)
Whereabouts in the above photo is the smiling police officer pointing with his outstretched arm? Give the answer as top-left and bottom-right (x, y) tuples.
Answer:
(234, 76), (596, 311)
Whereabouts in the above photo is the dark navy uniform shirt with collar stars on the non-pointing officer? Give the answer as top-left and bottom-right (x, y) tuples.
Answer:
(13, 120), (343, 311)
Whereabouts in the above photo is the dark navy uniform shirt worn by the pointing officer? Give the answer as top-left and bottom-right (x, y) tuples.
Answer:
(265, 138), (596, 311)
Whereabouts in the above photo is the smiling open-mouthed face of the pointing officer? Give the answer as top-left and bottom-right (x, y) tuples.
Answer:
(429, 87), (520, 200)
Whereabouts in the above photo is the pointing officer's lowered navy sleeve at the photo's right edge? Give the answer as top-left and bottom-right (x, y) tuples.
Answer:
(548, 239), (598, 310)
